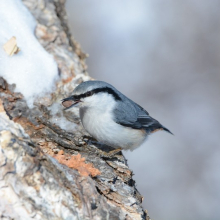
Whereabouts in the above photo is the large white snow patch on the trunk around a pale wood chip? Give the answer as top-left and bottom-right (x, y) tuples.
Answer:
(0, 0), (58, 107)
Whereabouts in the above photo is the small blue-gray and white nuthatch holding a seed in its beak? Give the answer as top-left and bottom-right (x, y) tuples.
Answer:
(62, 80), (172, 156)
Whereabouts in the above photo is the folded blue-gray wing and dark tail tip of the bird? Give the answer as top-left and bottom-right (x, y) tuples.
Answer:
(114, 99), (171, 133)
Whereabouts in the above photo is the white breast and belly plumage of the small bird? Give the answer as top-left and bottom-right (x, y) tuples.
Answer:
(80, 95), (146, 150)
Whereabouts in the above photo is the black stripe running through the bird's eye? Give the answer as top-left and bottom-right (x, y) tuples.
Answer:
(73, 87), (121, 101)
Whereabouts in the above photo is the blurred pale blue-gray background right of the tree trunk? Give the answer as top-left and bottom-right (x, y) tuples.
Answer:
(66, 0), (220, 220)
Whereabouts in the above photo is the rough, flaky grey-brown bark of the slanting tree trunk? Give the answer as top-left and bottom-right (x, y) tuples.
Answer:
(0, 0), (149, 219)
